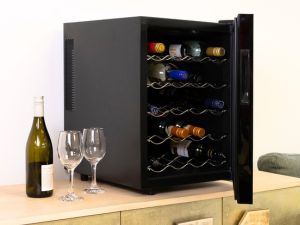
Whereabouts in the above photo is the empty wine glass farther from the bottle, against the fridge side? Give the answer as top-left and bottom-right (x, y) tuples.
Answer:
(82, 128), (106, 194)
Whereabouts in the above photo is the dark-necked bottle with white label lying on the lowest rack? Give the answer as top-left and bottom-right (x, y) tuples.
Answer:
(170, 140), (225, 162)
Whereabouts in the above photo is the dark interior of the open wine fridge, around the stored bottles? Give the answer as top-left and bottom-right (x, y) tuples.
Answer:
(145, 22), (231, 185)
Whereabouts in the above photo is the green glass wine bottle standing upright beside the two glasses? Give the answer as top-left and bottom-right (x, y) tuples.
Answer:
(26, 97), (53, 198)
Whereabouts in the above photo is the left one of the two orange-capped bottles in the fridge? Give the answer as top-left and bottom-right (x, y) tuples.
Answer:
(149, 120), (189, 138)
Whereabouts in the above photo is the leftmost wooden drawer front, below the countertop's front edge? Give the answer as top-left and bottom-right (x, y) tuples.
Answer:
(34, 212), (120, 225)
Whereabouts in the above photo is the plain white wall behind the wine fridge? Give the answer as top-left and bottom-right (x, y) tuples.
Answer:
(0, 0), (300, 184)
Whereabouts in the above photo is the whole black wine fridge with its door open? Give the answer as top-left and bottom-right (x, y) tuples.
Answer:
(64, 14), (253, 203)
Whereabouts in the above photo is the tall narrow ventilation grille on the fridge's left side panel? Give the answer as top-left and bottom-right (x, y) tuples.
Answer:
(64, 39), (75, 111)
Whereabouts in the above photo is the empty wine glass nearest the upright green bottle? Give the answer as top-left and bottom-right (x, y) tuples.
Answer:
(57, 131), (83, 201)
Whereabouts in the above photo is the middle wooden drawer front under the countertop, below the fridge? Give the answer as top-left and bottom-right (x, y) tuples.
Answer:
(121, 199), (222, 225)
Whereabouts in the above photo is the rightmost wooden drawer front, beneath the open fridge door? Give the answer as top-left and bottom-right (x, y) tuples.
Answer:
(223, 187), (300, 225)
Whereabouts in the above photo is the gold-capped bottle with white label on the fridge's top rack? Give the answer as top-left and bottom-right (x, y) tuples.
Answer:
(169, 41), (225, 57)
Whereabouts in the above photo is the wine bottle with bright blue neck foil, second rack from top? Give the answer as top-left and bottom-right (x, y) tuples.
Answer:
(148, 63), (188, 81)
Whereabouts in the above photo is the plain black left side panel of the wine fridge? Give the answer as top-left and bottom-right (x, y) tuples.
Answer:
(64, 18), (141, 188)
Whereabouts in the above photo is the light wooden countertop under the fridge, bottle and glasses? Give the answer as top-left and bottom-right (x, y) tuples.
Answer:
(0, 171), (300, 225)
